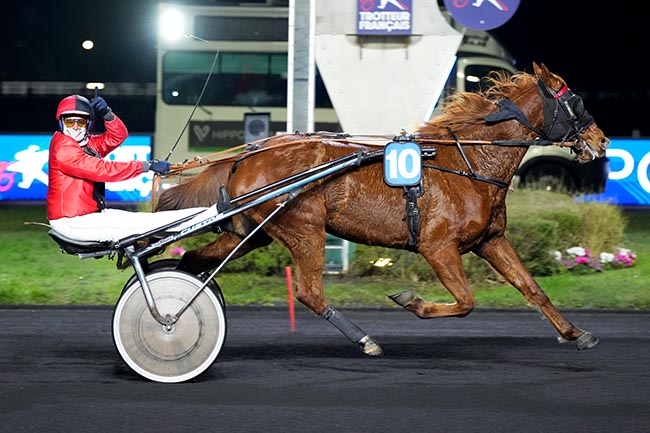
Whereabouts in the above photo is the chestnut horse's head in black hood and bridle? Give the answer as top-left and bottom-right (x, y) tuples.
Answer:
(533, 63), (609, 162)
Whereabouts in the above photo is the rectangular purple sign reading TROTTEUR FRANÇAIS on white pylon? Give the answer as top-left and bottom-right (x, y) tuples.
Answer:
(357, 0), (413, 35)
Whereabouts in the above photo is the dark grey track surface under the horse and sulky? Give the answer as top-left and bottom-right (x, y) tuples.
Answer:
(0, 306), (650, 433)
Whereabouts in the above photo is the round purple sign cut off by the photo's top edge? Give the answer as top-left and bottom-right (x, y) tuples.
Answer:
(445, 0), (519, 30)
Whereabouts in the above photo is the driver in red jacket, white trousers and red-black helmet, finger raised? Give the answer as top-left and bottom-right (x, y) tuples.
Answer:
(47, 90), (206, 242)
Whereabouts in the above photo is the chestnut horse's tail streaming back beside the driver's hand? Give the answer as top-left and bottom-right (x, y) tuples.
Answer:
(154, 161), (233, 212)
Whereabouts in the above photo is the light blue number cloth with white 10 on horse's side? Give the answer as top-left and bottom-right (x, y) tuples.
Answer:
(384, 141), (422, 186)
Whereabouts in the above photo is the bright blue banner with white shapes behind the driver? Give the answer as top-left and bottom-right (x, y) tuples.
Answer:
(0, 135), (153, 202)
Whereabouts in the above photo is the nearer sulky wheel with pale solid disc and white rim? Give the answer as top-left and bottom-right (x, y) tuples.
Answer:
(113, 270), (226, 383)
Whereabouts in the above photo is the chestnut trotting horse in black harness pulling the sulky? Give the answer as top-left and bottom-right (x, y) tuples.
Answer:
(156, 63), (610, 355)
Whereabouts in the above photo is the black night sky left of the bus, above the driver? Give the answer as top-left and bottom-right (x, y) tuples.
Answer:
(0, 0), (158, 82)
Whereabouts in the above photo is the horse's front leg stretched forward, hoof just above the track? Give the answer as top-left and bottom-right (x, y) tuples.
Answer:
(476, 236), (598, 350)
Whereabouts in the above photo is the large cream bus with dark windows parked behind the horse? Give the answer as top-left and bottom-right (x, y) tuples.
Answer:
(154, 2), (608, 193)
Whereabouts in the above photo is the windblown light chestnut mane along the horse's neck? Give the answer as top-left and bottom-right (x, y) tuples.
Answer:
(419, 71), (537, 135)
